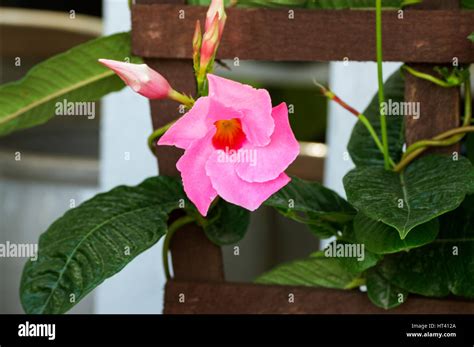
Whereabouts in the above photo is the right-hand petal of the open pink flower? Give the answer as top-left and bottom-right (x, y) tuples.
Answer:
(235, 103), (300, 182)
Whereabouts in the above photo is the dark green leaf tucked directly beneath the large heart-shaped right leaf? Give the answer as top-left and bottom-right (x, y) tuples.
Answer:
(354, 213), (439, 254)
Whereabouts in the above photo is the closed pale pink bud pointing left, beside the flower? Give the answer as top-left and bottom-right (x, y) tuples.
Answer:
(99, 59), (173, 99)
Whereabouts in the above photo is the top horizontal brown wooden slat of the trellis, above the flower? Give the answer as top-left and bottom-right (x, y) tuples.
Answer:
(132, 4), (474, 63)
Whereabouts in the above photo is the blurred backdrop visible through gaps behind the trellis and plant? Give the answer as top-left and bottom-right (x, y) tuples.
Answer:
(0, 0), (399, 313)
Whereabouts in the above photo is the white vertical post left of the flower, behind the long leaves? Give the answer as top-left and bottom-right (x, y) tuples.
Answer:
(95, 0), (165, 313)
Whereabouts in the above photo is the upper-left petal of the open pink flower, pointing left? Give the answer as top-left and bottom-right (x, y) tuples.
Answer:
(158, 97), (243, 149)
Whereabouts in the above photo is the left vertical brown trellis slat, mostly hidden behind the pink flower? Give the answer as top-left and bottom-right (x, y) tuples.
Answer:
(146, 59), (224, 281)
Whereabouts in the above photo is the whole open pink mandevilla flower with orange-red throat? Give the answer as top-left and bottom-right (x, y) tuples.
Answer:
(158, 74), (299, 216)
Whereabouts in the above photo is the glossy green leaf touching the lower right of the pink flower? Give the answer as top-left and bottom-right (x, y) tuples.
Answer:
(265, 177), (356, 238)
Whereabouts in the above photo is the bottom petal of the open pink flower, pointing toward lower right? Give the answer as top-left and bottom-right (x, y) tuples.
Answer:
(206, 151), (291, 211)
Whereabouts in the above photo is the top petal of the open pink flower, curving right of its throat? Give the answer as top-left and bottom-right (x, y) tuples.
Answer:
(207, 74), (275, 146)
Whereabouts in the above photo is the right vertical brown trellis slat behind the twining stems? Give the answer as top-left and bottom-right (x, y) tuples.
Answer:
(405, 0), (460, 154)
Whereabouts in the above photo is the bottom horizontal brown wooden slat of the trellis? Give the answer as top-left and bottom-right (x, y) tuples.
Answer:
(164, 281), (474, 314)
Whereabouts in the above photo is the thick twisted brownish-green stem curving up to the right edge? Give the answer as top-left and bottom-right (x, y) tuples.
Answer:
(394, 79), (474, 171)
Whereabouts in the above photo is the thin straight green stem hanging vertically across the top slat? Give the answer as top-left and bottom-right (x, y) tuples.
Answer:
(375, 0), (390, 170)
